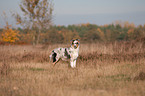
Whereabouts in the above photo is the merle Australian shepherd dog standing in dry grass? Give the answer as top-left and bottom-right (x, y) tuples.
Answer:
(50, 39), (80, 68)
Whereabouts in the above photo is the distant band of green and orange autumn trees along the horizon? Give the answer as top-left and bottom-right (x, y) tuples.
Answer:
(0, 22), (145, 44)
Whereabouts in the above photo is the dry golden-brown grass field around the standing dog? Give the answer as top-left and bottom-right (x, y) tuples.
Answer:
(0, 42), (145, 96)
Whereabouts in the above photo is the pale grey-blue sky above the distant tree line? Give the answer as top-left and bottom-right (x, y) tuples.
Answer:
(0, 0), (145, 27)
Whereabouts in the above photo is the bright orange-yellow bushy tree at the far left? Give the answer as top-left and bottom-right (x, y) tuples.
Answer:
(2, 24), (19, 43)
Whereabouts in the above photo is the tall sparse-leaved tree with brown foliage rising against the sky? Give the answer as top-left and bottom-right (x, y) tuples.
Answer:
(14, 0), (53, 44)
